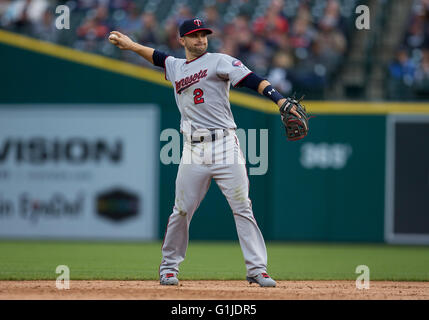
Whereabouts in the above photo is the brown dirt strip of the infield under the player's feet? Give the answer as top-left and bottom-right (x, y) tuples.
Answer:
(0, 280), (429, 300)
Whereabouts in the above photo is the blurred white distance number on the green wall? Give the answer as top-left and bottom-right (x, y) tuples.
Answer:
(300, 142), (353, 170)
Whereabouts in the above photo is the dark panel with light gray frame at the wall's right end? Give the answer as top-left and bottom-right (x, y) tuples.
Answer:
(385, 114), (429, 244)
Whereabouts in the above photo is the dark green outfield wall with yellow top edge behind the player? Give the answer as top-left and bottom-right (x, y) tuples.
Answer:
(0, 34), (427, 242)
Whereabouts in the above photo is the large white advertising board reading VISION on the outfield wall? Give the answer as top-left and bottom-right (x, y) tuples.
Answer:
(0, 105), (159, 240)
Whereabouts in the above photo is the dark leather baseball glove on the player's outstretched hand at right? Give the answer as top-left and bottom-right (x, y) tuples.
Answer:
(280, 97), (310, 141)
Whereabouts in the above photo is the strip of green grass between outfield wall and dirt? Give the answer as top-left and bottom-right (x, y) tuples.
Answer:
(0, 240), (429, 281)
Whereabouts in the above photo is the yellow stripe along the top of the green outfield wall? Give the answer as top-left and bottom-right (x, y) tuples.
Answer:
(0, 30), (429, 115)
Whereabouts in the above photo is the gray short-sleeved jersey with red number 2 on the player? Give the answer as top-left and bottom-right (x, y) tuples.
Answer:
(165, 52), (252, 134)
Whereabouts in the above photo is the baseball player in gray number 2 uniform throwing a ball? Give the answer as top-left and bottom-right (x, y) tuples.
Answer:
(109, 18), (301, 287)
